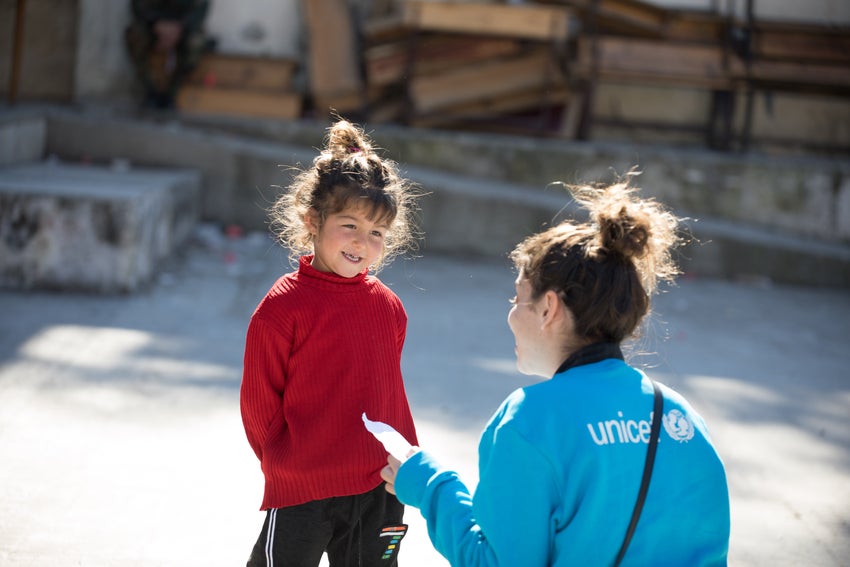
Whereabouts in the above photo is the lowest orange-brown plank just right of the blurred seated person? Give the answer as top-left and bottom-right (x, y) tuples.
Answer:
(177, 85), (302, 119)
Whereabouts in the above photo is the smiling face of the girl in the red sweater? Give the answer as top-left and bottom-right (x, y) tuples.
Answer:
(305, 205), (389, 278)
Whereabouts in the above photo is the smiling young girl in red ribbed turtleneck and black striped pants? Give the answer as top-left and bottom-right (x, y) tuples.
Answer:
(240, 120), (416, 567)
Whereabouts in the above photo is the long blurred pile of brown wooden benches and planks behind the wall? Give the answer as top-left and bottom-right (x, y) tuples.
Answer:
(178, 0), (850, 153)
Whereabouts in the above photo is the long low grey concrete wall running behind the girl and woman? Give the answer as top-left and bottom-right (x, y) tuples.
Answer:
(0, 110), (850, 286)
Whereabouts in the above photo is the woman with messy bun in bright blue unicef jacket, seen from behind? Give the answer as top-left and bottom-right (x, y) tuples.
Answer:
(382, 175), (729, 567)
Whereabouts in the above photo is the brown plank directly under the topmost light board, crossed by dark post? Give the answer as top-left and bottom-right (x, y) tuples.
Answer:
(364, 35), (522, 86)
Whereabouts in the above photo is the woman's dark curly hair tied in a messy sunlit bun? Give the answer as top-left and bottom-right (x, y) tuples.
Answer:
(510, 173), (681, 343)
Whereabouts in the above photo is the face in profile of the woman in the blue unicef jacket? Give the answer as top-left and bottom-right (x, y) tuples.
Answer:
(508, 273), (549, 378)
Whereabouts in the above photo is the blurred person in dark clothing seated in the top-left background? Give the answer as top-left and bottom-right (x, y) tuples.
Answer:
(125, 0), (210, 109)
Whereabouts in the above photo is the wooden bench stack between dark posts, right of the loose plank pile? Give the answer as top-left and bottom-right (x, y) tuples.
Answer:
(558, 0), (743, 147)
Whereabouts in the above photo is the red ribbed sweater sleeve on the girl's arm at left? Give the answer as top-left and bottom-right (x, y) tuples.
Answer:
(239, 315), (289, 461)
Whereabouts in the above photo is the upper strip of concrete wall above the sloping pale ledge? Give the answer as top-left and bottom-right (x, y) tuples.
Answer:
(164, 112), (850, 250)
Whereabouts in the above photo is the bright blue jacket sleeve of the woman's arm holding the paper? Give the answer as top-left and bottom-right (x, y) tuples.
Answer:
(395, 429), (558, 567)
